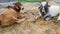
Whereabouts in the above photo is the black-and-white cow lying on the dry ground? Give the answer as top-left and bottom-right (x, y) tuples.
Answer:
(39, 2), (60, 21)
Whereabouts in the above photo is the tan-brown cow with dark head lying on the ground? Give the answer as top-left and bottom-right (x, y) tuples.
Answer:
(0, 2), (23, 27)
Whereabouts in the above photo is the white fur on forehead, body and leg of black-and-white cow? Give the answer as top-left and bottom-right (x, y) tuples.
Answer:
(41, 2), (60, 20)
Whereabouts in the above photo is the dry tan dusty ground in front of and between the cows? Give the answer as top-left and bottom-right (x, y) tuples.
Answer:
(0, 0), (60, 34)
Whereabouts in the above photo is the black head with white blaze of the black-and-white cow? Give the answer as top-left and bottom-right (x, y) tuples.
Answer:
(39, 2), (50, 17)
